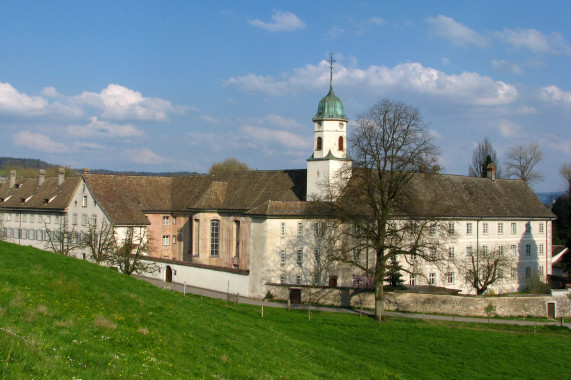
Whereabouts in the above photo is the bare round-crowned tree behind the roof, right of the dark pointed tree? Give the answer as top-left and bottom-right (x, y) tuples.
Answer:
(505, 143), (544, 185)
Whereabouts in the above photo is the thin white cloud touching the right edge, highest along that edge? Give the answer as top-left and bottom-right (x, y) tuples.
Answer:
(495, 29), (571, 55)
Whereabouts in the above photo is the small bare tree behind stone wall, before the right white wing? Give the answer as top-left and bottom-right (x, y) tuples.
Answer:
(455, 246), (516, 295)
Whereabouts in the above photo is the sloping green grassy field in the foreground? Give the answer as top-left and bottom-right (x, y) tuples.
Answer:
(0, 242), (571, 379)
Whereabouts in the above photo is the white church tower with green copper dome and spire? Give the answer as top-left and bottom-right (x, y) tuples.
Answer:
(307, 53), (352, 200)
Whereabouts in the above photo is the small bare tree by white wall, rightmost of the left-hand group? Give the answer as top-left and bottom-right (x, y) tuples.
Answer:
(108, 227), (157, 275)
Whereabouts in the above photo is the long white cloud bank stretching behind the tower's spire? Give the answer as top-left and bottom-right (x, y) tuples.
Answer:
(224, 61), (518, 106)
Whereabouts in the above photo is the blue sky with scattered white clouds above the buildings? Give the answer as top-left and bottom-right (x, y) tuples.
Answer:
(0, 1), (571, 191)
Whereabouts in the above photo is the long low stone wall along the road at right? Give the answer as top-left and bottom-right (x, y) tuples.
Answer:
(266, 285), (571, 318)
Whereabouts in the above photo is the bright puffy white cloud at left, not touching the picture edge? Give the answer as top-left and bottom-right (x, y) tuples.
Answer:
(76, 84), (184, 121)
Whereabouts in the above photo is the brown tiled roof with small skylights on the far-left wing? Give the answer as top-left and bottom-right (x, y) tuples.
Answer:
(0, 177), (81, 211)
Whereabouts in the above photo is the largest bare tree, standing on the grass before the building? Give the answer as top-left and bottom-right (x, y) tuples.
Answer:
(324, 100), (447, 323)
